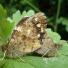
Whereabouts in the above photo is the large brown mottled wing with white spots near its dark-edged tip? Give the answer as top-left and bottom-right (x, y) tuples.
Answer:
(4, 12), (47, 57)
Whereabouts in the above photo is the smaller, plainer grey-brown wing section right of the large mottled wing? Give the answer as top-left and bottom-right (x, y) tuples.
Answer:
(35, 34), (58, 57)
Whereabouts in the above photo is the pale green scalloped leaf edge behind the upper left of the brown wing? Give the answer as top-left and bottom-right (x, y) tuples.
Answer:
(13, 10), (35, 23)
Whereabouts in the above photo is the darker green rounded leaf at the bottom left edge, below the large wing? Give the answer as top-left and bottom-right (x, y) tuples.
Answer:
(2, 59), (34, 68)
